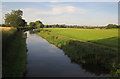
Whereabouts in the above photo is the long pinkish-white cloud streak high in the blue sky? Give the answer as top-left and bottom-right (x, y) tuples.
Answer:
(22, 6), (87, 15)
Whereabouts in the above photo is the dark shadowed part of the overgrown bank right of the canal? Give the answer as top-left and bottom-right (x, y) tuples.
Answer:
(62, 41), (117, 76)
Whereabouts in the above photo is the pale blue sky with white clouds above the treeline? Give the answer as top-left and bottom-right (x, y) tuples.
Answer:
(2, 1), (118, 26)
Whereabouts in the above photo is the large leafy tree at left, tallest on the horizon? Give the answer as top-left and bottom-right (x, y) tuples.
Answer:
(5, 10), (27, 27)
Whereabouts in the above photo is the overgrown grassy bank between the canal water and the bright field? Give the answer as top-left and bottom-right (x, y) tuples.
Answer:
(38, 29), (120, 77)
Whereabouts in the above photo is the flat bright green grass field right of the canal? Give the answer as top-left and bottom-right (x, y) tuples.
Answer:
(45, 28), (118, 47)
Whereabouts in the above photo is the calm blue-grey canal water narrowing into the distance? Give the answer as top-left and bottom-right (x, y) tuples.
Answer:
(26, 32), (108, 77)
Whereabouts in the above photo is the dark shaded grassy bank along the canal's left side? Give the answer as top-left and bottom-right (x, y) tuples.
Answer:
(2, 28), (27, 77)
